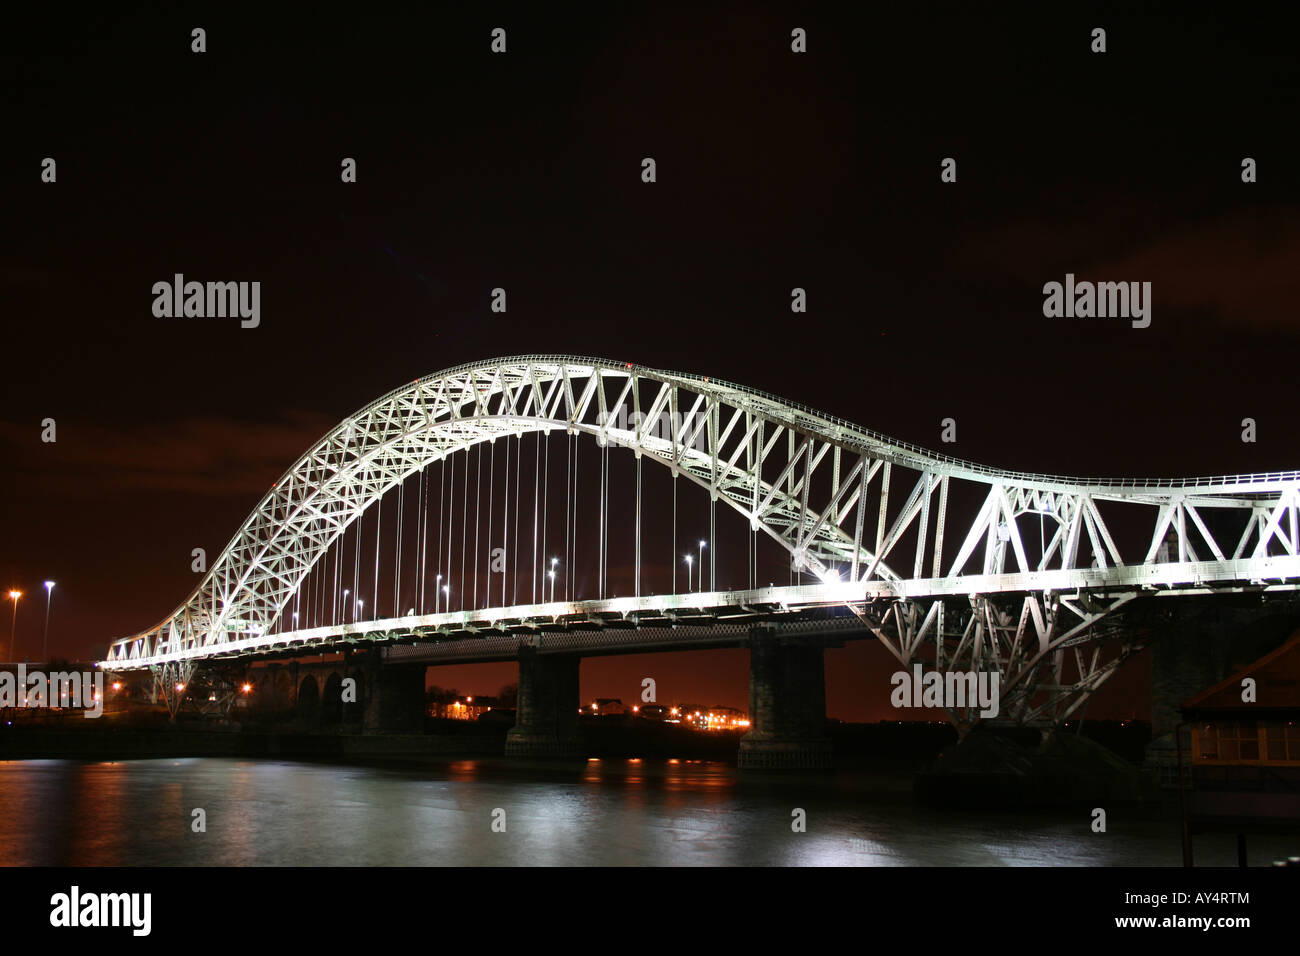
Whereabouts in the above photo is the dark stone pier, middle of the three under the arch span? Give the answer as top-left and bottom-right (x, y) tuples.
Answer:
(506, 648), (584, 757)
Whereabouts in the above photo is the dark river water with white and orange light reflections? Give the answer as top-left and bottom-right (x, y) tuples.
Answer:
(0, 757), (1295, 866)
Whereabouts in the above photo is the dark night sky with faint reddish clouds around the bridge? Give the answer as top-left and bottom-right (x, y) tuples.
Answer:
(0, 5), (1300, 719)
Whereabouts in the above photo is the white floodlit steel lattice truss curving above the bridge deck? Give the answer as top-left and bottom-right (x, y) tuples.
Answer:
(108, 355), (1300, 663)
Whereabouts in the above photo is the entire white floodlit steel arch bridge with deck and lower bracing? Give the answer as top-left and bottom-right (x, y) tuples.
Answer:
(101, 355), (1300, 723)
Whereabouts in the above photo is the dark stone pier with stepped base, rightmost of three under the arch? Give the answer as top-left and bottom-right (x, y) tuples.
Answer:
(740, 628), (832, 770)
